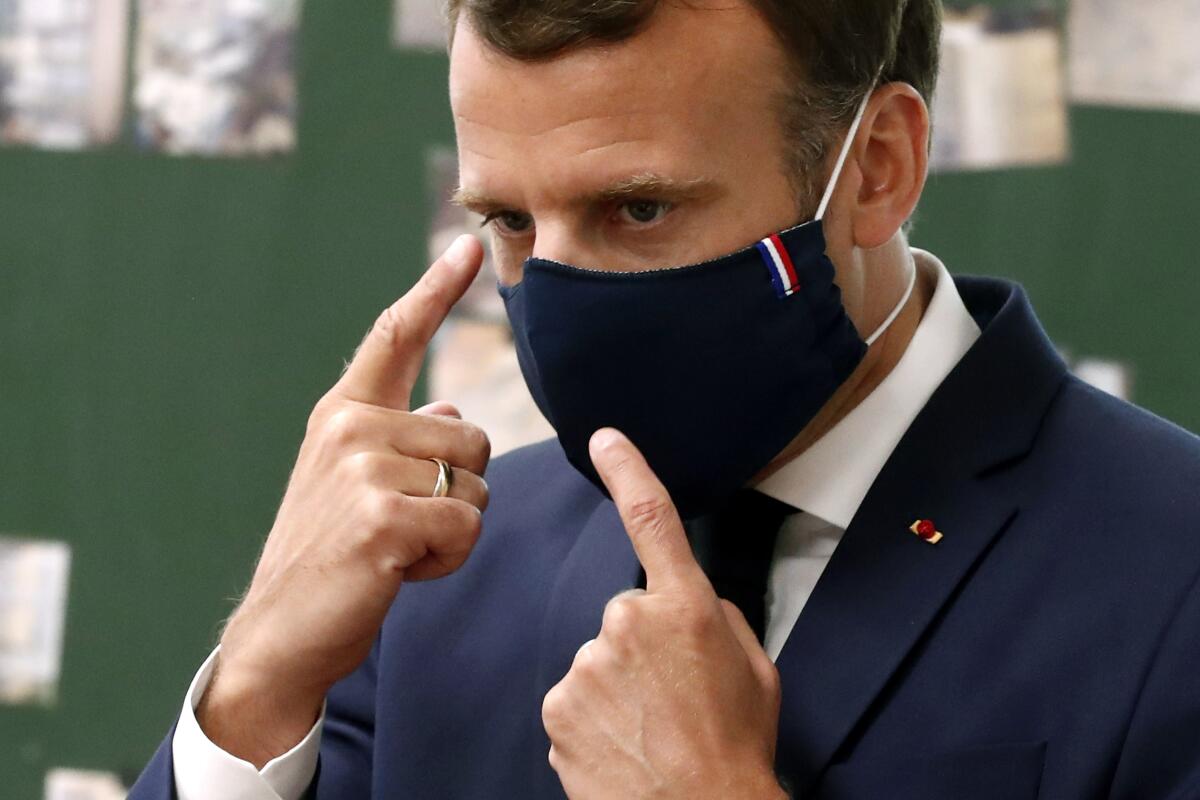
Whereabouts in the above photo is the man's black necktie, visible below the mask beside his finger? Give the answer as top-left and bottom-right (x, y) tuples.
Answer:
(637, 489), (798, 642)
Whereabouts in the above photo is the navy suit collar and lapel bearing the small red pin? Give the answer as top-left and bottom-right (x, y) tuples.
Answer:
(776, 278), (1066, 795)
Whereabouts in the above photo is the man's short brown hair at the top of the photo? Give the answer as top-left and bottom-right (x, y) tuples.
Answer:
(446, 0), (942, 209)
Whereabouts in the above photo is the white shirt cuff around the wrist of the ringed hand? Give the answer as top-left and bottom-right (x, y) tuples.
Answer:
(170, 645), (325, 800)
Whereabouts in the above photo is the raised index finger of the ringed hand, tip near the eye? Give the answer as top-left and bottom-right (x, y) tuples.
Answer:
(334, 234), (484, 410)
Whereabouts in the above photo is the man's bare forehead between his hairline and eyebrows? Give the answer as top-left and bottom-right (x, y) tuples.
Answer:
(450, 2), (786, 203)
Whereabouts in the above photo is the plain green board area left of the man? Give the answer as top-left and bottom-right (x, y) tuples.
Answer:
(0, 0), (452, 800)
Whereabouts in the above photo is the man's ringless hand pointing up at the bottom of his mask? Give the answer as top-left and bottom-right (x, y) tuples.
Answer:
(542, 429), (786, 800)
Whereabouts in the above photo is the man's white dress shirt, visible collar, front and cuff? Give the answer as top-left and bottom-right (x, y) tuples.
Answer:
(172, 249), (979, 800)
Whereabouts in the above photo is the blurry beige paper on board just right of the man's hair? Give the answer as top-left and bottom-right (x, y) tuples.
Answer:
(930, 6), (1069, 172)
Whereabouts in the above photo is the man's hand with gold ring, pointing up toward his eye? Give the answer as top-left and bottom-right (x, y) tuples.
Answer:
(197, 236), (491, 768)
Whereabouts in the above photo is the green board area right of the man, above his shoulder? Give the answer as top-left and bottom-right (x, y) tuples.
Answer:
(913, 108), (1200, 431)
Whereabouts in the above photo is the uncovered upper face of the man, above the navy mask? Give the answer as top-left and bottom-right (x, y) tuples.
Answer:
(450, 1), (803, 284)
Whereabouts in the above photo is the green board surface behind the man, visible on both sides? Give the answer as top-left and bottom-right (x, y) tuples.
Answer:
(0, 0), (1200, 799)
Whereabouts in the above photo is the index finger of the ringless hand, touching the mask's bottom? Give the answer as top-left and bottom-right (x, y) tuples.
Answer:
(589, 428), (713, 594)
